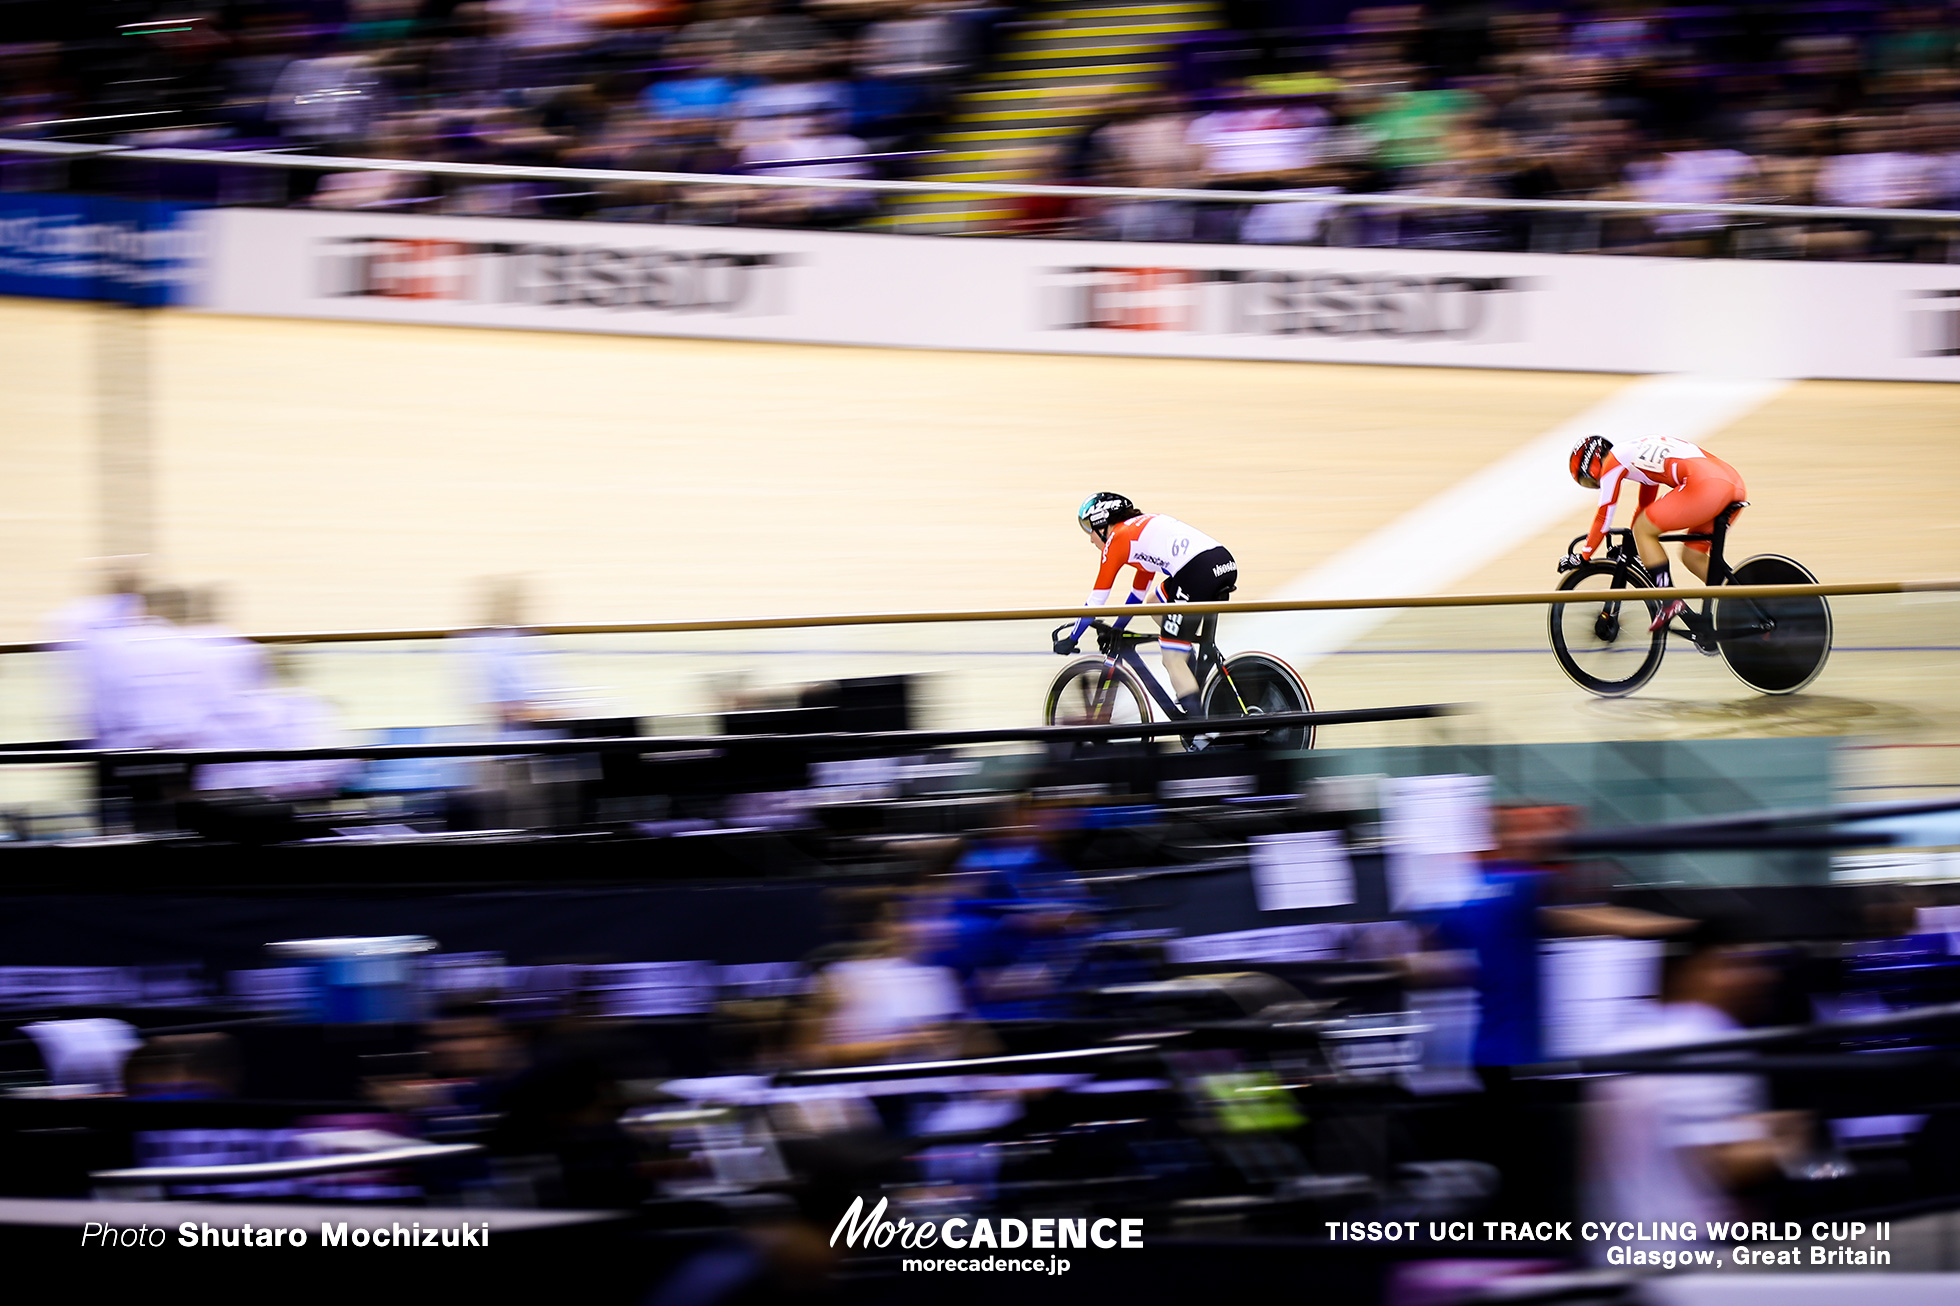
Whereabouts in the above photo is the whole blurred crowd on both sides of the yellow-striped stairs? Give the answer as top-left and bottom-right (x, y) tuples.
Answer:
(0, 0), (1960, 249)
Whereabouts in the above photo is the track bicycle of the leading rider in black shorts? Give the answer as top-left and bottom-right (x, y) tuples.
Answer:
(1041, 618), (1313, 751)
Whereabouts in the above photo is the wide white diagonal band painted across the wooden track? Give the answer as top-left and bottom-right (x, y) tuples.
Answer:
(1225, 368), (1789, 669)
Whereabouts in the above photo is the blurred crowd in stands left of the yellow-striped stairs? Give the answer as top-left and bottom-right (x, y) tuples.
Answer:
(0, 0), (1005, 224)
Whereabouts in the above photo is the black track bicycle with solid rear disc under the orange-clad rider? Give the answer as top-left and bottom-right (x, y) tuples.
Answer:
(1550, 502), (1831, 698)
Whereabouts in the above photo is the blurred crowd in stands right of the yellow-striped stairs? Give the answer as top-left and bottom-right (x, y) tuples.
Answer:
(1025, 2), (1960, 259)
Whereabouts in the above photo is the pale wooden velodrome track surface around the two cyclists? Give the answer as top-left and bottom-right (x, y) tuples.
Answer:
(0, 300), (1960, 803)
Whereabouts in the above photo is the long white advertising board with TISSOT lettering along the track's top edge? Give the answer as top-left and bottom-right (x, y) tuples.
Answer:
(200, 210), (1960, 380)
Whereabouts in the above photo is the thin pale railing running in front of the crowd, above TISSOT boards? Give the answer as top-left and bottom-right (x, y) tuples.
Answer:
(0, 139), (1960, 226)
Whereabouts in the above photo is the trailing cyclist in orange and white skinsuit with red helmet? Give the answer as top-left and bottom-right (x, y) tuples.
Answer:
(1560, 435), (1748, 629)
